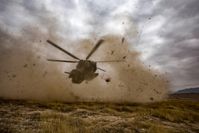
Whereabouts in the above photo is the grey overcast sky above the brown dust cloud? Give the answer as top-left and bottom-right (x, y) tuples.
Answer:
(0, 0), (199, 89)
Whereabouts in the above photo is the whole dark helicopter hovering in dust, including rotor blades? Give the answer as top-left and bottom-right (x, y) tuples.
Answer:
(47, 39), (123, 84)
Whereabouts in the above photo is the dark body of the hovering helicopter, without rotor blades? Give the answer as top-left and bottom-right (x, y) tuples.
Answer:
(69, 60), (98, 84)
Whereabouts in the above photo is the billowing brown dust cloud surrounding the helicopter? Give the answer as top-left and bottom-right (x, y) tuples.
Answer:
(0, 28), (168, 102)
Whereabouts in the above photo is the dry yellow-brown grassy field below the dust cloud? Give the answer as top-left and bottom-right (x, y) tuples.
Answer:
(0, 99), (199, 133)
